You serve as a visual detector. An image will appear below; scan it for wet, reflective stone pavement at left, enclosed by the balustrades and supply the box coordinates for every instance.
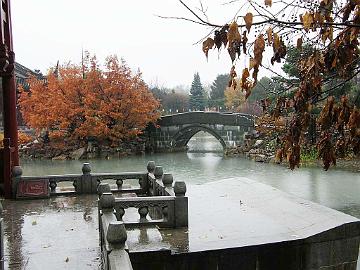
[2,195,101,270]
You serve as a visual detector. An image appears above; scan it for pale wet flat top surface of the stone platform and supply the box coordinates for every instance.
[128,178,360,253]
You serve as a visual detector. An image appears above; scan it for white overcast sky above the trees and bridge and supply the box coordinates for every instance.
[12,0,276,90]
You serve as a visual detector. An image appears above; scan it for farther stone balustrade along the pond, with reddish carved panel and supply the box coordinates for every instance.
[12,161,186,198]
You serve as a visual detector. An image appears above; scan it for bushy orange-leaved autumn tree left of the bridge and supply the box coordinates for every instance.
[19,56,159,146]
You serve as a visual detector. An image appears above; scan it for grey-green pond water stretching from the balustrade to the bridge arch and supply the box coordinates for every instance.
[21,134,360,218]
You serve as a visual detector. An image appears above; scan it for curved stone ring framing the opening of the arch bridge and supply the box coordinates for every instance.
[171,125,226,150]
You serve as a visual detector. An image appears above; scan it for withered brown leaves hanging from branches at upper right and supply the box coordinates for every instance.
[195,0,360,170]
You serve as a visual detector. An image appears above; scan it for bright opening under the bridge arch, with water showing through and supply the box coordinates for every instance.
[187,131,223,152]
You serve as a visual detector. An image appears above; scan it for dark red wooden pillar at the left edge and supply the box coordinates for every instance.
[0,0,19,198]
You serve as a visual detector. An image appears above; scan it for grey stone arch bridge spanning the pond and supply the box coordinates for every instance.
[146,112,254,152]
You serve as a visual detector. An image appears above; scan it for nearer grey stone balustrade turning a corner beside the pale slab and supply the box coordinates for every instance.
[97,166,188,270]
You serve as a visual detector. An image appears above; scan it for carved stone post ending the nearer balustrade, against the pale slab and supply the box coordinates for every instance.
[174,181,189,228]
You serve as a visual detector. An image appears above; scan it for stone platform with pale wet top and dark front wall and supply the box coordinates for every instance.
[127,178,360,270]
